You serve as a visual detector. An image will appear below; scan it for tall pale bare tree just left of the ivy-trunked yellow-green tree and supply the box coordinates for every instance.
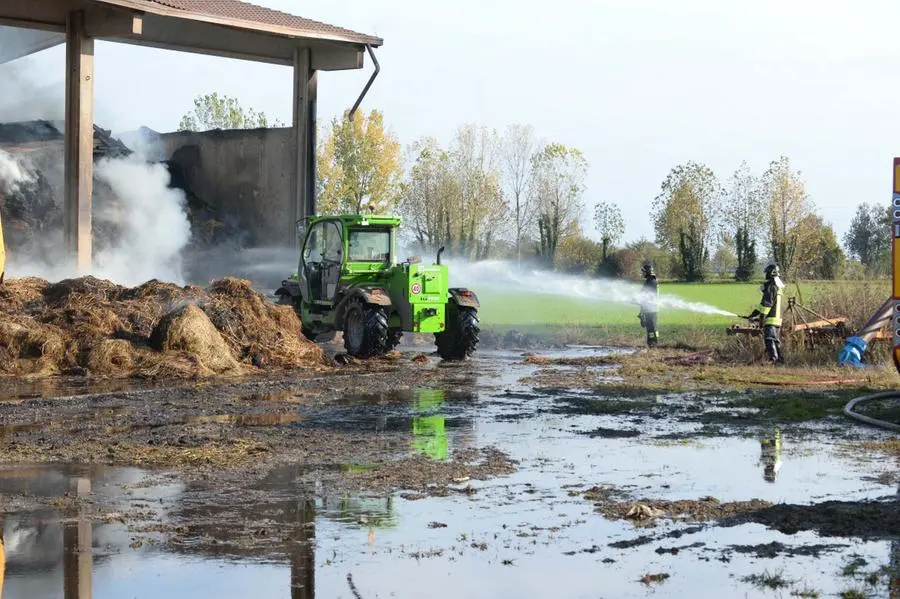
[501,125,535,262]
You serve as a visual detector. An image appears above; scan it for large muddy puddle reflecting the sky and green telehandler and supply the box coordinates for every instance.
[0,348,900,599]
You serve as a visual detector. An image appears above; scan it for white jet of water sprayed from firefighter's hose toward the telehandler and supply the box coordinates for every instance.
[447,260,735,316]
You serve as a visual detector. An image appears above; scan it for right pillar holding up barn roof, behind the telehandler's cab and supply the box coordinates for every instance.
[289,48,315,247]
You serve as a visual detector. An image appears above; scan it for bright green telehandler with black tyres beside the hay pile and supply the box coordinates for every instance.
[275,215,479,360]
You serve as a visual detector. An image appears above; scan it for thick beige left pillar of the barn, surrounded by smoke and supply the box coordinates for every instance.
[63,11,94,272]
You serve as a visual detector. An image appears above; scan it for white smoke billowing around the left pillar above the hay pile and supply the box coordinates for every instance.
[0,58,197,285]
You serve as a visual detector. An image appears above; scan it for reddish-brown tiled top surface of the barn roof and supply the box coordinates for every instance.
[147,0,382,46]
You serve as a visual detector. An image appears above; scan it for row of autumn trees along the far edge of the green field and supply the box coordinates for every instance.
[182,95,891,281]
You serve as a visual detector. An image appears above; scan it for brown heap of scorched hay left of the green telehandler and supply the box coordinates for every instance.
[0,277,325,378]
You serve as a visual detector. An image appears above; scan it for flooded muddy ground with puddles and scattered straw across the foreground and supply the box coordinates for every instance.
[0,347,900,597]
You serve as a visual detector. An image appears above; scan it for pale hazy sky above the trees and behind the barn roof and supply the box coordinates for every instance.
[0,0,900,245]
